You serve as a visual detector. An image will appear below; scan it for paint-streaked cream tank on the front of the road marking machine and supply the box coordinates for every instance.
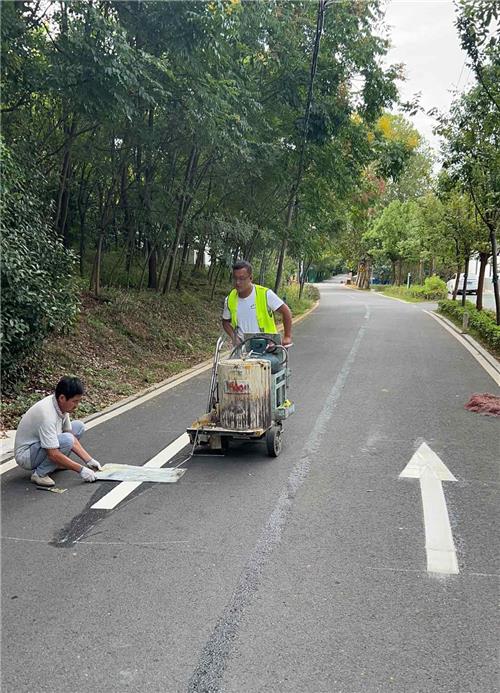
[218,358,272,431]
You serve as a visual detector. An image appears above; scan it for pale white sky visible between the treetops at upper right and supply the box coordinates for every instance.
[385,0,474,158]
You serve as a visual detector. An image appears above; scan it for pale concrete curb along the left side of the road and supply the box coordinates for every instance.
[0,299,320,464]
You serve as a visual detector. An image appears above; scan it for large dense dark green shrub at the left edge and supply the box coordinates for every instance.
[0,142,78,389]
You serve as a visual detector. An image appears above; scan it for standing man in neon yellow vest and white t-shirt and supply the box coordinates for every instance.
[222,260,292,347]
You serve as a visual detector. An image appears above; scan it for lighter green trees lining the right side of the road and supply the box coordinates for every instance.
[337,0,500,325]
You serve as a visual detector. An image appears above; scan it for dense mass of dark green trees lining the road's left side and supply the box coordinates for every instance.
[0,0,402,402]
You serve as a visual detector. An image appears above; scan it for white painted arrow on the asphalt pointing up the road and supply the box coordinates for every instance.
[399,443,459,575]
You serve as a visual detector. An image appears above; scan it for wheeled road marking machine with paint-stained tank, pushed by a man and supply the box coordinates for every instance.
[187,333,295,457]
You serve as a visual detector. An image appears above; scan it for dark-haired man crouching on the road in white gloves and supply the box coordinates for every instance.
[14,377,101,486]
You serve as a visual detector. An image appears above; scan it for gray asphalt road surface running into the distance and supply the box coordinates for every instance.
[1,283,500,693]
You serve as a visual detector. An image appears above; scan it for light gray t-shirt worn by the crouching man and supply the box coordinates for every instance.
[14,395,71,466]
